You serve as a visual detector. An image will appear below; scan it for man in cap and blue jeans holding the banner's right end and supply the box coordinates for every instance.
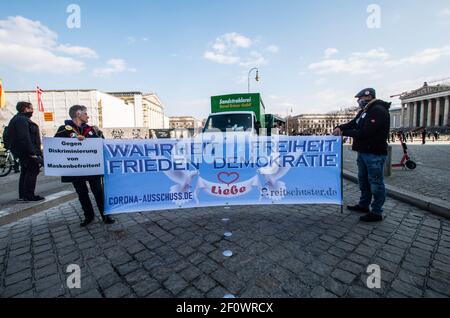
[333,88,391,222]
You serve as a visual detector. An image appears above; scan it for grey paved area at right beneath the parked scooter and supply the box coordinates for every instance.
[344,142,450,201]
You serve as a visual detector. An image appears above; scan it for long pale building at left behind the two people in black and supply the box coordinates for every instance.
[0,89,168,136]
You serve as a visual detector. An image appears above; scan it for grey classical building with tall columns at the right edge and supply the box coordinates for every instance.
[399,82,450,129]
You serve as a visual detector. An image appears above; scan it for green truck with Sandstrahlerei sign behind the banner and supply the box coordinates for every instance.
[203,94,266,134]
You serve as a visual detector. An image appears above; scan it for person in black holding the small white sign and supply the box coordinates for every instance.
[55,105,115,227]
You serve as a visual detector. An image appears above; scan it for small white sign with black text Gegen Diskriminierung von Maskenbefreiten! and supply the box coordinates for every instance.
[43,137,104,177]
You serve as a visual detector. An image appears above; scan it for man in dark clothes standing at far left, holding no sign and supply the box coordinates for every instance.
[8,102,45,202]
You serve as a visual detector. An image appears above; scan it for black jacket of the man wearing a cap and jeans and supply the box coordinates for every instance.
[339,99,391,155]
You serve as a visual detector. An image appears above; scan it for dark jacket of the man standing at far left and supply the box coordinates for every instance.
[7,113,42,158]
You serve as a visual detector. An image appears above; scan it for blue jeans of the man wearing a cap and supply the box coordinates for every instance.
[357,152,387,215]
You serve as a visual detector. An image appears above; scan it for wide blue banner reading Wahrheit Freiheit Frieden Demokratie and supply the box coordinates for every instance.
[104,136,342,214]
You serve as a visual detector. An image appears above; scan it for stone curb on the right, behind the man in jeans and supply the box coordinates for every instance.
[344,169,450,219]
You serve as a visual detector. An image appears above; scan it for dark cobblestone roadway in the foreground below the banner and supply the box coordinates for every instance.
[0,183,450,298]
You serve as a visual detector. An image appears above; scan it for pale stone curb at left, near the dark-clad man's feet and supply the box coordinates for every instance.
[0,191,77,226]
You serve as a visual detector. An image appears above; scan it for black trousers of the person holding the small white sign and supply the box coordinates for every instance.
[72,177,105,219]
